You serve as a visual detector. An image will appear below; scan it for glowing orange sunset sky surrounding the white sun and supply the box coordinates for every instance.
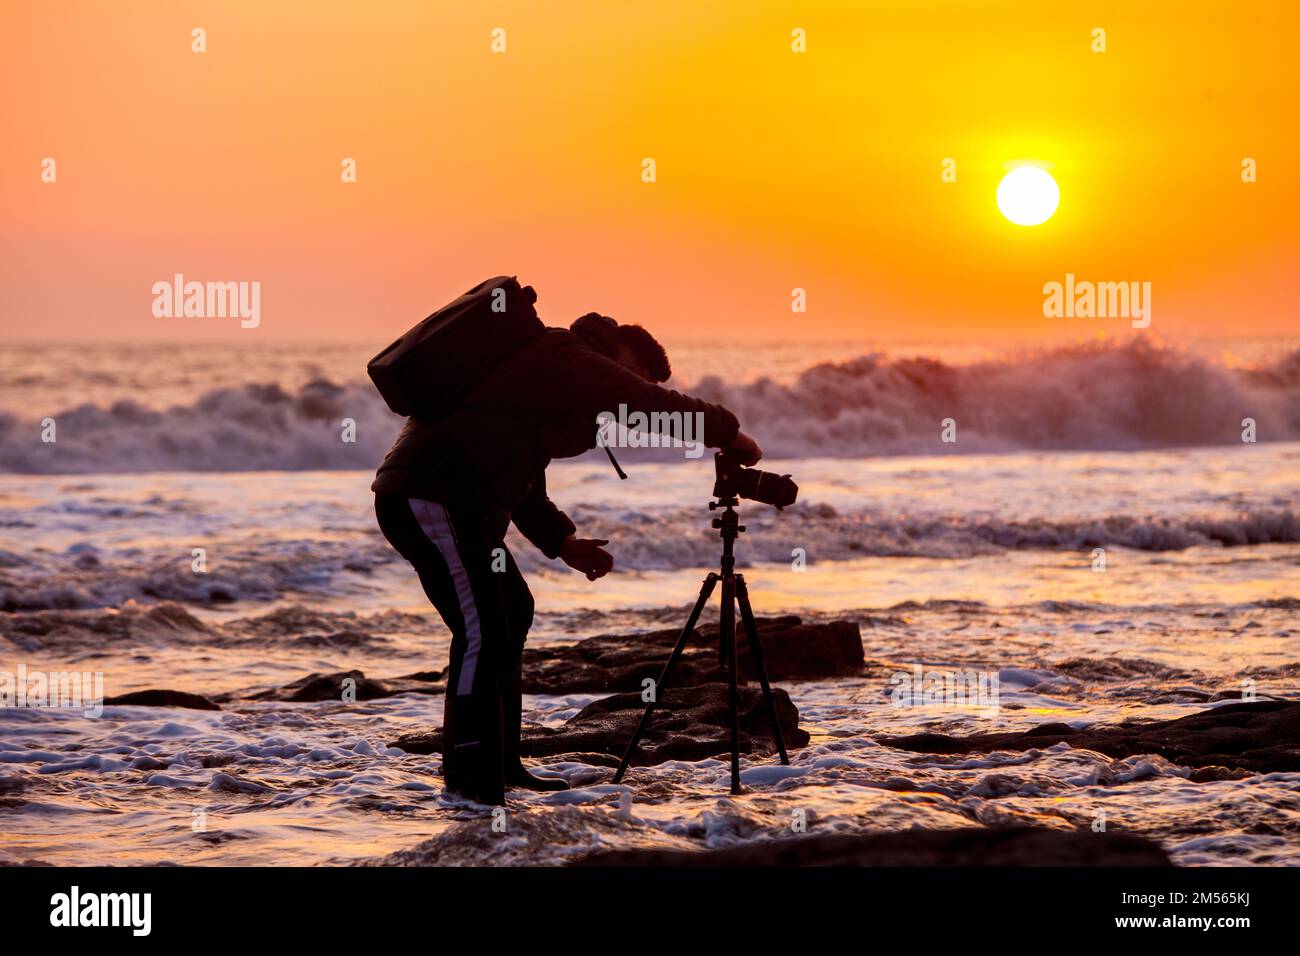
[0,0,1300,343]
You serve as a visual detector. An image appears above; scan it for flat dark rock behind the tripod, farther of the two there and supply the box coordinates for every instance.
[524,617,865,693]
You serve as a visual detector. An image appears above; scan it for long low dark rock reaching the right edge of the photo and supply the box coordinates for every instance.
[878,701,1300,779]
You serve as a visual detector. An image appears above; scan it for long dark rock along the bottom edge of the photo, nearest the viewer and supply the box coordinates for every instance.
[569,827,1173,866]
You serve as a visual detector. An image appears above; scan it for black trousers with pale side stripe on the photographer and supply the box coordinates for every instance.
[374,492,533,803]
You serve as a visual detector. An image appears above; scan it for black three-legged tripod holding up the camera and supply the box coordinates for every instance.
[614,489,790,793]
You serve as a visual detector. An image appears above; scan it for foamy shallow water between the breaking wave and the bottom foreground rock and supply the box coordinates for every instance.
[0,445,1300,865]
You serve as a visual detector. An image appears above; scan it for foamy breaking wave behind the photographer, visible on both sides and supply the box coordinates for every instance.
[0,339,1300,473]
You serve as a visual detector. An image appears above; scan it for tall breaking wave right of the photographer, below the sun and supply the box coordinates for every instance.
[696,339,1300,457]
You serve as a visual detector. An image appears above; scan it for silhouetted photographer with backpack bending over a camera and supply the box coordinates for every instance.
[368,277,762,804]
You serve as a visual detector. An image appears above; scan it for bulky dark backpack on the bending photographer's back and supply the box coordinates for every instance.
[365,276,545,420]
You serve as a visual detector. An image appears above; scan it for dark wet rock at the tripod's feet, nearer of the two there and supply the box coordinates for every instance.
[393,683,809,766]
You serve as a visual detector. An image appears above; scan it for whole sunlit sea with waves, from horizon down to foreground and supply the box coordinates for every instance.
[0,337,1300,866]
